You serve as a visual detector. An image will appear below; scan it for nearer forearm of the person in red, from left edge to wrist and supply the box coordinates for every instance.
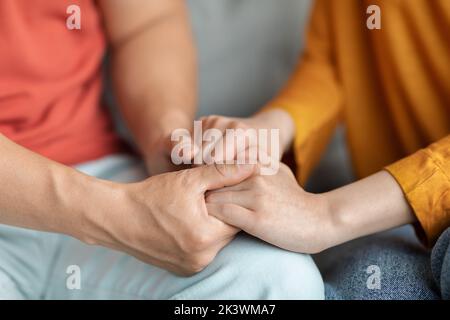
[0,134,114,240]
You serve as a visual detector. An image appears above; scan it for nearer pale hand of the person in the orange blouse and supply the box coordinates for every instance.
[206,164,335,253]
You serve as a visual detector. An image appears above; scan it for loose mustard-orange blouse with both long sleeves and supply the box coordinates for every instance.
[268,0,450,243]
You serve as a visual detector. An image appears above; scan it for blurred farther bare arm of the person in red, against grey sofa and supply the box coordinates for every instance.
[100,0,197,173]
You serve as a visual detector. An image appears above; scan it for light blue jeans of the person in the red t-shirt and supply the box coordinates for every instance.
[0,155,324,299]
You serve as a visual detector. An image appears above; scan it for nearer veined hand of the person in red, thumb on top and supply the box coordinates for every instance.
[82,165,254,275]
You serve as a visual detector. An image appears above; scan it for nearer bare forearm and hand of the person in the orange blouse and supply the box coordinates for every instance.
[207,165,415,253]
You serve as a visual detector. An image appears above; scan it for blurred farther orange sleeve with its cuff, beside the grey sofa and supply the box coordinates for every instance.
[265,0,342,183]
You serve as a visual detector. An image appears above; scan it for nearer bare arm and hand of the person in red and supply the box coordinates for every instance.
[0,134,252,274]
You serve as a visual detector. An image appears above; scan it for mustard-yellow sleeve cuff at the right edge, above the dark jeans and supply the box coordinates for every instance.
[386,136,450,245]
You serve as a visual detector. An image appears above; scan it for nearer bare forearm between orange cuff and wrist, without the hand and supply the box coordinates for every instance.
[324,171,416,246]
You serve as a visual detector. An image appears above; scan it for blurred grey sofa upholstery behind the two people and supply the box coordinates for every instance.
[107,0,351,191]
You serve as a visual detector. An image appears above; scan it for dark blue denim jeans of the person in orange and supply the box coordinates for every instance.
[315,226,450,300]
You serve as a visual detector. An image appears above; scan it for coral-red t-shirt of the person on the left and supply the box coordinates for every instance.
[0,0,122,165]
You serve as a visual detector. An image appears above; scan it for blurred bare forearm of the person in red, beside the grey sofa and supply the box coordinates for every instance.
[112,2,197,154]
